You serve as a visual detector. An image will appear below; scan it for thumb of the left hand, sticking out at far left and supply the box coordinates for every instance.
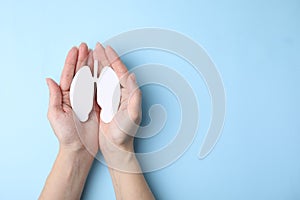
[46,78,62,110]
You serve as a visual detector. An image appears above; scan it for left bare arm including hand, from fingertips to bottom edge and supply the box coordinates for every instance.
[39,43,99,200]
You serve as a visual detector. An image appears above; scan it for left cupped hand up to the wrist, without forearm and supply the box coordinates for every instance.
[46,43,100,156]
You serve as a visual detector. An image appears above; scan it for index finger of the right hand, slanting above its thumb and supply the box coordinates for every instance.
[105,46,128,87]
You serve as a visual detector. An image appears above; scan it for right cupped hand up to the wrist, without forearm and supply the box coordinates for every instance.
[93,43,141,157]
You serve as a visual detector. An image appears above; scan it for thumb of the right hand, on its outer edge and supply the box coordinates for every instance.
[127,74,142,122]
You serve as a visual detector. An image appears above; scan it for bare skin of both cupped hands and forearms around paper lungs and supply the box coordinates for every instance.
[39,43,154,200]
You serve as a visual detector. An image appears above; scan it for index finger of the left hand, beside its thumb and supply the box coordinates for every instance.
[60,47,78,91]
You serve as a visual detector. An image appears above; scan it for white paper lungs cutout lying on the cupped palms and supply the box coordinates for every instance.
[70,61,120,123]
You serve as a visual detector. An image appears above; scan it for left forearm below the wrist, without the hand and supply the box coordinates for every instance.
[39,148,93,200]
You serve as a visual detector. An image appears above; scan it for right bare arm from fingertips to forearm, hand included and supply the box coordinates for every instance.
[94,43,154,200]
